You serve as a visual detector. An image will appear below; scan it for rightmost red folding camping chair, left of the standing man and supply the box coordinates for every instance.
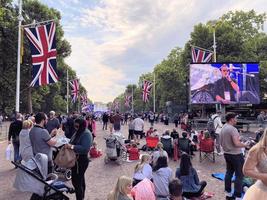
[199,138,215,163]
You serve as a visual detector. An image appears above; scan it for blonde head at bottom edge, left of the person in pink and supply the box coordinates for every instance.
[108,176,133,200]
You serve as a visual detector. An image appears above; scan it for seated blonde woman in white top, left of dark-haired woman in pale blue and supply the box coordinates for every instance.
[133,154,152,186]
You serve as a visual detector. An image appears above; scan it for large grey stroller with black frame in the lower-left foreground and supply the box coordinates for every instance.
[12,153,74,200]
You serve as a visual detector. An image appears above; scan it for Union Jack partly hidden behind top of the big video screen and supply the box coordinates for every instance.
[191,46,213,63]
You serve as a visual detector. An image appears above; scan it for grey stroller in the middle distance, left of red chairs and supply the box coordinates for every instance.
[104,135,127,165]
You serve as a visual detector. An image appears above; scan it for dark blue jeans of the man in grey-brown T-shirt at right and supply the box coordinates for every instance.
[224,153,244,197]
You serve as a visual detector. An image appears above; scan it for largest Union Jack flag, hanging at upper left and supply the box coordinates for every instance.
[25,22,58,87]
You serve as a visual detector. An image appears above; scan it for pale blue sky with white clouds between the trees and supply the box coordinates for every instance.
[39,0,267,103]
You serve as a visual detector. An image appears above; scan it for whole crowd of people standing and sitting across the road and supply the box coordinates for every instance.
[4,111,267,200]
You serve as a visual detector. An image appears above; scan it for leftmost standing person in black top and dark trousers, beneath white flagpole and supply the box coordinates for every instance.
[8,113,23,162]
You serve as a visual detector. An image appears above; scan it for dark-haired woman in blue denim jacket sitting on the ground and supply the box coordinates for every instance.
[176,153,207,199]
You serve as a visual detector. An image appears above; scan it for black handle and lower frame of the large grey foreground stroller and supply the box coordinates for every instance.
[11,161,74,200]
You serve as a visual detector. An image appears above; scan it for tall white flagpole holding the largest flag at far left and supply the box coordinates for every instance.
[16,0,23,112]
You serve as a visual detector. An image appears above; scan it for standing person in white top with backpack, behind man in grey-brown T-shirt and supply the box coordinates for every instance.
[214,111,223,156]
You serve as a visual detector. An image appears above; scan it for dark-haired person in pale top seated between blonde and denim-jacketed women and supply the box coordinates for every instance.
[152,156,172,200]
